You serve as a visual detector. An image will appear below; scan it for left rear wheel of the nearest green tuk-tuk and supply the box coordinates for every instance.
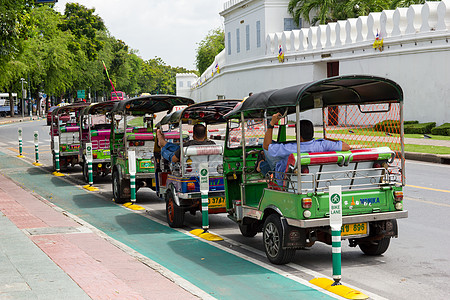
[263,214,295,265]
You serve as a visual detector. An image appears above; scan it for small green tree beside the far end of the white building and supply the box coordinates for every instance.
[196,28,225,74]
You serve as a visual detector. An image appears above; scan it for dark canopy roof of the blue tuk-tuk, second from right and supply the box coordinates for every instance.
[156,99,241,127]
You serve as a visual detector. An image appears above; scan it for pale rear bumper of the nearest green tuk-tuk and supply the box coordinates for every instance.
[286,210,408,228]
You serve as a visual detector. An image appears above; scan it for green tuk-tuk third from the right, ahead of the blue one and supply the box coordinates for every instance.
[110,95,194,203]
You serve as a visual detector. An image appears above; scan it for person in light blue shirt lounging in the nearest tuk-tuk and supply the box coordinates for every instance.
[256,113,350,176]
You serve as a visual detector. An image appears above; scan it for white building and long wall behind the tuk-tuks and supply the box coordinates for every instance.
[177,0,450,125]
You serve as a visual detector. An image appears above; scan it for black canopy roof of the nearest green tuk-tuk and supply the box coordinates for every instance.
[226,75,403,118]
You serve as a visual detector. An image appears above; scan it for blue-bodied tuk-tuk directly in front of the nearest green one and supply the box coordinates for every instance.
[157,100,240,227]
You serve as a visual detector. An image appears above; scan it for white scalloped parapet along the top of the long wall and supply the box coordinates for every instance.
[192,0,450,86]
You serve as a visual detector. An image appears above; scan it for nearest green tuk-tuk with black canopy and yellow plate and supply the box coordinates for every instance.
[224,75,408,264]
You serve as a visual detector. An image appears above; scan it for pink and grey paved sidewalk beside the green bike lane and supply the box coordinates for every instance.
[0,175,198,300]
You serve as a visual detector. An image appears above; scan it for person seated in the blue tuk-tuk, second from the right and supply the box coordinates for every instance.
[156,124,216,162]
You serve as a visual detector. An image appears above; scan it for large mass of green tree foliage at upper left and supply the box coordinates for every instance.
[0,0,195,106]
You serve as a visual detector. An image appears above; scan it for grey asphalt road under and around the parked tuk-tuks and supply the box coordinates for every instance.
[0,120,450,299]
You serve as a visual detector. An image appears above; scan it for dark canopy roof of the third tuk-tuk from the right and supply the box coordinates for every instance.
[114,95,194,115]
